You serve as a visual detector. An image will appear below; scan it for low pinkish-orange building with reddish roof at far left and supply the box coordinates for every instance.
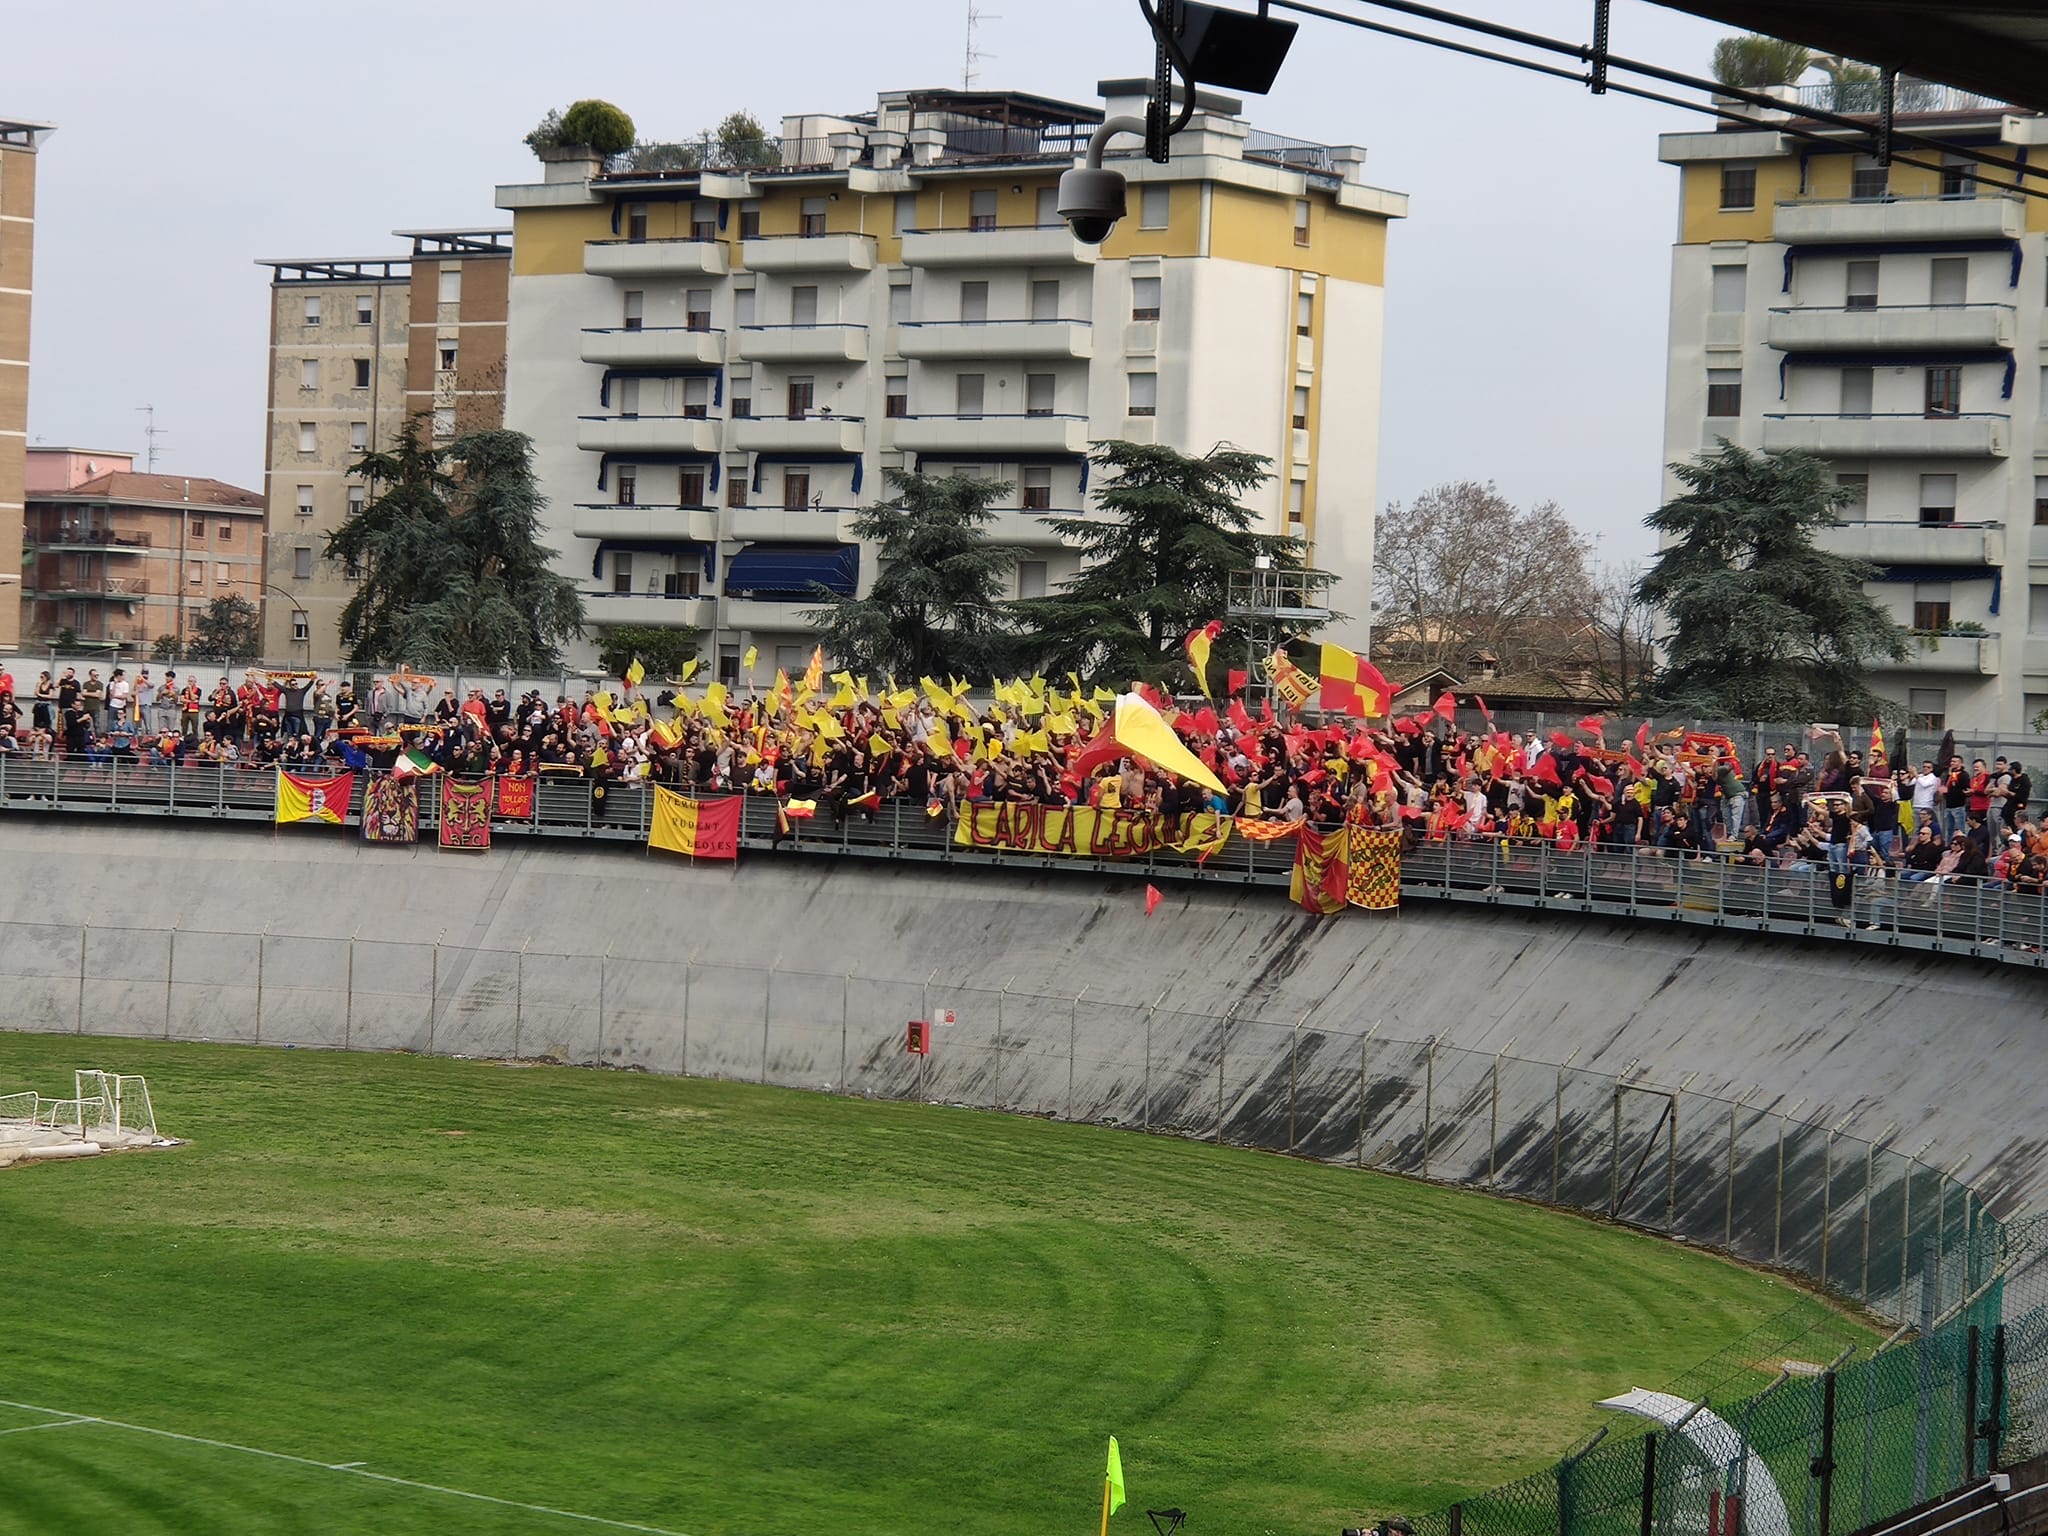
[20,449,264,657]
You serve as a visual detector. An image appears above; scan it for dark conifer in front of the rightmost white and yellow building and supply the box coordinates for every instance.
[1636,442,1907,721]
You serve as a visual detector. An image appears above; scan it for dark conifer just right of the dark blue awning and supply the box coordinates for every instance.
[807,469,1018,678]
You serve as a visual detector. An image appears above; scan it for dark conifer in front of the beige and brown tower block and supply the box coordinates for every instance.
[326,416,584,672]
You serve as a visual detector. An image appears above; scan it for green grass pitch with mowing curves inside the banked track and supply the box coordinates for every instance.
[0,1034,1826,1536]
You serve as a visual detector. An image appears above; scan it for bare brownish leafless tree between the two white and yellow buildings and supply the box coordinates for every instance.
[1374,479,1593,674]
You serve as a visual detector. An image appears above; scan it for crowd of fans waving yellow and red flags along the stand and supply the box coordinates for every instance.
[0,668,2048,913]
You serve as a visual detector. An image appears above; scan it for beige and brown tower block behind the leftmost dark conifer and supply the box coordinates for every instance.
[258,229,512,666]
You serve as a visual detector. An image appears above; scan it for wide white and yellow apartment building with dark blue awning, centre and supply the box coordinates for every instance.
[498,80,1407,680]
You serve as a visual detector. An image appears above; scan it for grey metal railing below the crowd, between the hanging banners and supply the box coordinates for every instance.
[0,761,2048,969]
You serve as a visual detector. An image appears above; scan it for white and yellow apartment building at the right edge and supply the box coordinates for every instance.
[1659,82,2048,735]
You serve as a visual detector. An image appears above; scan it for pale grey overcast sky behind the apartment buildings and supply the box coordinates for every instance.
[0,0,1720,561]
